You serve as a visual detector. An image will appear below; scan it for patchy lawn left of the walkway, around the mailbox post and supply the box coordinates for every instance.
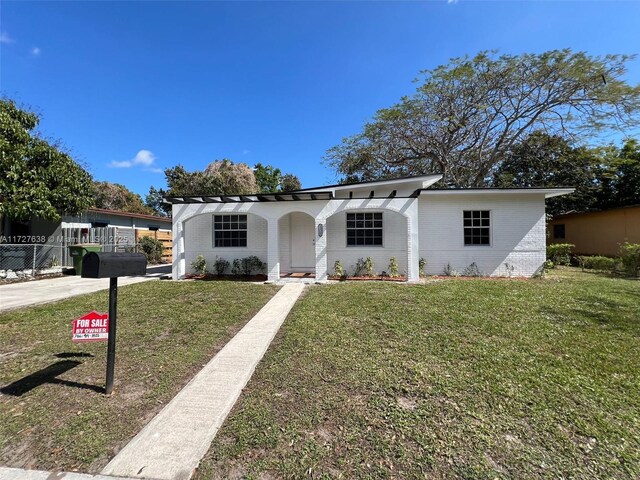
[0,282,277,472]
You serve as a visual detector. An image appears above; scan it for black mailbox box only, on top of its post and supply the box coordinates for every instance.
[82,252,147,278]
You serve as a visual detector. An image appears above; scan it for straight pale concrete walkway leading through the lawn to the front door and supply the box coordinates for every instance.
[102,283,304,480]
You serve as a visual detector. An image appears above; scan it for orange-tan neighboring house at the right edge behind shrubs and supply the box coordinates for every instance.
[547,205,640,256]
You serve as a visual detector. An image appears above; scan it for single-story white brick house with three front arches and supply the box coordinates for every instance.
[166,175,573,282]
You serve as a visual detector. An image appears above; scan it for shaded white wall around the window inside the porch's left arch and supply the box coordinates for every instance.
[184,213,267,273]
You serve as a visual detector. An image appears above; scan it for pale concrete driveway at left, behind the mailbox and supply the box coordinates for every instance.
[0,265,171,312]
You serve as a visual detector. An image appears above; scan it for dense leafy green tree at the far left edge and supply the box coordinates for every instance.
[0,98,93,224]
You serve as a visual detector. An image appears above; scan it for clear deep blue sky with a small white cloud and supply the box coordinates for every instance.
[0,0,640,195]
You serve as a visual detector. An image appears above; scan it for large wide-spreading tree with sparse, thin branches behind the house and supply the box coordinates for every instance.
[325,49,640,187]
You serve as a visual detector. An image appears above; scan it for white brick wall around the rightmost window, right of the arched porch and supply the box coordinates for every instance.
[418,192,546,276]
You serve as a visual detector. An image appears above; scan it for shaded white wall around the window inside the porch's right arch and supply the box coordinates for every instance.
[327,210,407,275]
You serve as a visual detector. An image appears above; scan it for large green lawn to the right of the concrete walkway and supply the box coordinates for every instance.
[196,270,640,480]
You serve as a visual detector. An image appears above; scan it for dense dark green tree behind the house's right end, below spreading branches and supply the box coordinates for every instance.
[492,131,604,215]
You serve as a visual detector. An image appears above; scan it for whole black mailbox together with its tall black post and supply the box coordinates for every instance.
[82,252,147,395]
